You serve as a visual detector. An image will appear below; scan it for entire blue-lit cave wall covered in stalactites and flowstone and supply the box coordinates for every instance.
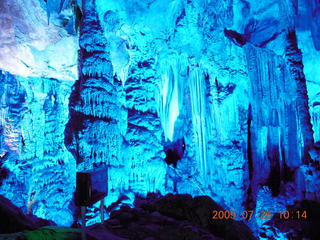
[0,0,320,233]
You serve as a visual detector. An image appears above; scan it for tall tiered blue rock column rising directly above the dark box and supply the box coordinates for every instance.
[69,1,127,174]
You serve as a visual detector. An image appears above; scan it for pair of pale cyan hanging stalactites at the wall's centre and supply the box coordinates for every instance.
[158,55,208,175]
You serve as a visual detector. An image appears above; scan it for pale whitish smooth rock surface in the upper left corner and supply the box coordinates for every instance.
[0,0,78,80]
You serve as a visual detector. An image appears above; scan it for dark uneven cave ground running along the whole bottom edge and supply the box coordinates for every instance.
[0,193,320,240]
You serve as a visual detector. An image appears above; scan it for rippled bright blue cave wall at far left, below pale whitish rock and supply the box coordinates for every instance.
[0,72,76,225]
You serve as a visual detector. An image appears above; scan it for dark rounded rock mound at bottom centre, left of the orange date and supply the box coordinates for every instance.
[101,194,256,240]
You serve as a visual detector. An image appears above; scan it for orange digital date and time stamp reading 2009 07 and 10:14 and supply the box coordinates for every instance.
[211,210,308,220]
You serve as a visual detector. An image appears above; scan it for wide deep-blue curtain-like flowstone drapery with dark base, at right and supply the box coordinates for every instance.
[245,44,303,203]
